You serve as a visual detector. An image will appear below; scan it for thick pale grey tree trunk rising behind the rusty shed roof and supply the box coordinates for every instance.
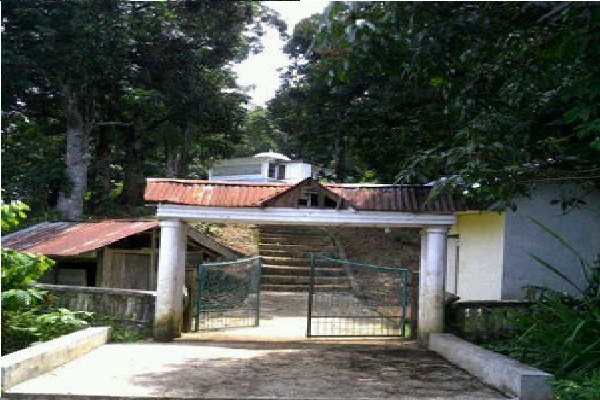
[57,83,90,221]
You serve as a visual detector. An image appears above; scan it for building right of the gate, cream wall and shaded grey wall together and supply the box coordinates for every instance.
[446,184,600,301]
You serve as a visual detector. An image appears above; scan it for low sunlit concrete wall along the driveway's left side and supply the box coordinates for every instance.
[1,327,110,390]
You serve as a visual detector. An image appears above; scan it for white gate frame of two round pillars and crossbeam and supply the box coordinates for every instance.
[154,211,456,344]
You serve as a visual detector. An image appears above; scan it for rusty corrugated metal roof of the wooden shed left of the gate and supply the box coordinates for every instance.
[2,220,158,256]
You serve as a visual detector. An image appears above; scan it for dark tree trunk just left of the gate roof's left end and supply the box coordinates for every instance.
[121,121,146,207]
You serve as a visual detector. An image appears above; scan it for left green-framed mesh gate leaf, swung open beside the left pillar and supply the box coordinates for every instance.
[192,257,262,332]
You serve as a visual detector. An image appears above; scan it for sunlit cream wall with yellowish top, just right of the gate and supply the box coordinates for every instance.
[446,211,504,300]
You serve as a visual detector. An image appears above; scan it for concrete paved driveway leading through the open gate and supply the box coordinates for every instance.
[3,294,506,400]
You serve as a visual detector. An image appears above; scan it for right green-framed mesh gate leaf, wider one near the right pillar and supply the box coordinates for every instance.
[306,254,409,337]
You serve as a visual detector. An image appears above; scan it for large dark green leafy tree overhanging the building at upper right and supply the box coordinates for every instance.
[315,2,600,208]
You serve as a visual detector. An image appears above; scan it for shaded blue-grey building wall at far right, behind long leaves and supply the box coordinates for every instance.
[502,184,600,299]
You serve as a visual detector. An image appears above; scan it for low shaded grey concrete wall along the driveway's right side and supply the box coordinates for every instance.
[429,333,554,400]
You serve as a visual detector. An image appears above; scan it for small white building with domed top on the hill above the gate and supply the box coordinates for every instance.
[208,151,321,183]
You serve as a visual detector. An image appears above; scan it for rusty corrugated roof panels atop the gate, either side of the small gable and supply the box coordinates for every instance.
[144,178,466,213]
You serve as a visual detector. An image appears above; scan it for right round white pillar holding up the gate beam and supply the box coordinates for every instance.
[417,226,448,343]
